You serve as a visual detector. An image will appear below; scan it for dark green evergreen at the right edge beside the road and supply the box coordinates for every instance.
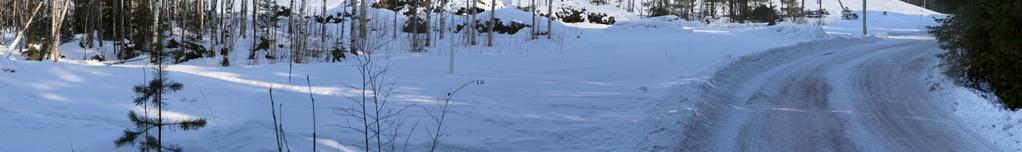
[930,0,1022,109]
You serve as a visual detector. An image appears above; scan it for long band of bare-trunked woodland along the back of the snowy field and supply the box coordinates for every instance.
[0,0,838,66]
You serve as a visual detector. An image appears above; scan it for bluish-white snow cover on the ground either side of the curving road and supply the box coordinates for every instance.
[0,0,1020,151]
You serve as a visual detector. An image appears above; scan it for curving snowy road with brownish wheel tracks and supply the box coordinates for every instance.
[680,39,1000,151]
